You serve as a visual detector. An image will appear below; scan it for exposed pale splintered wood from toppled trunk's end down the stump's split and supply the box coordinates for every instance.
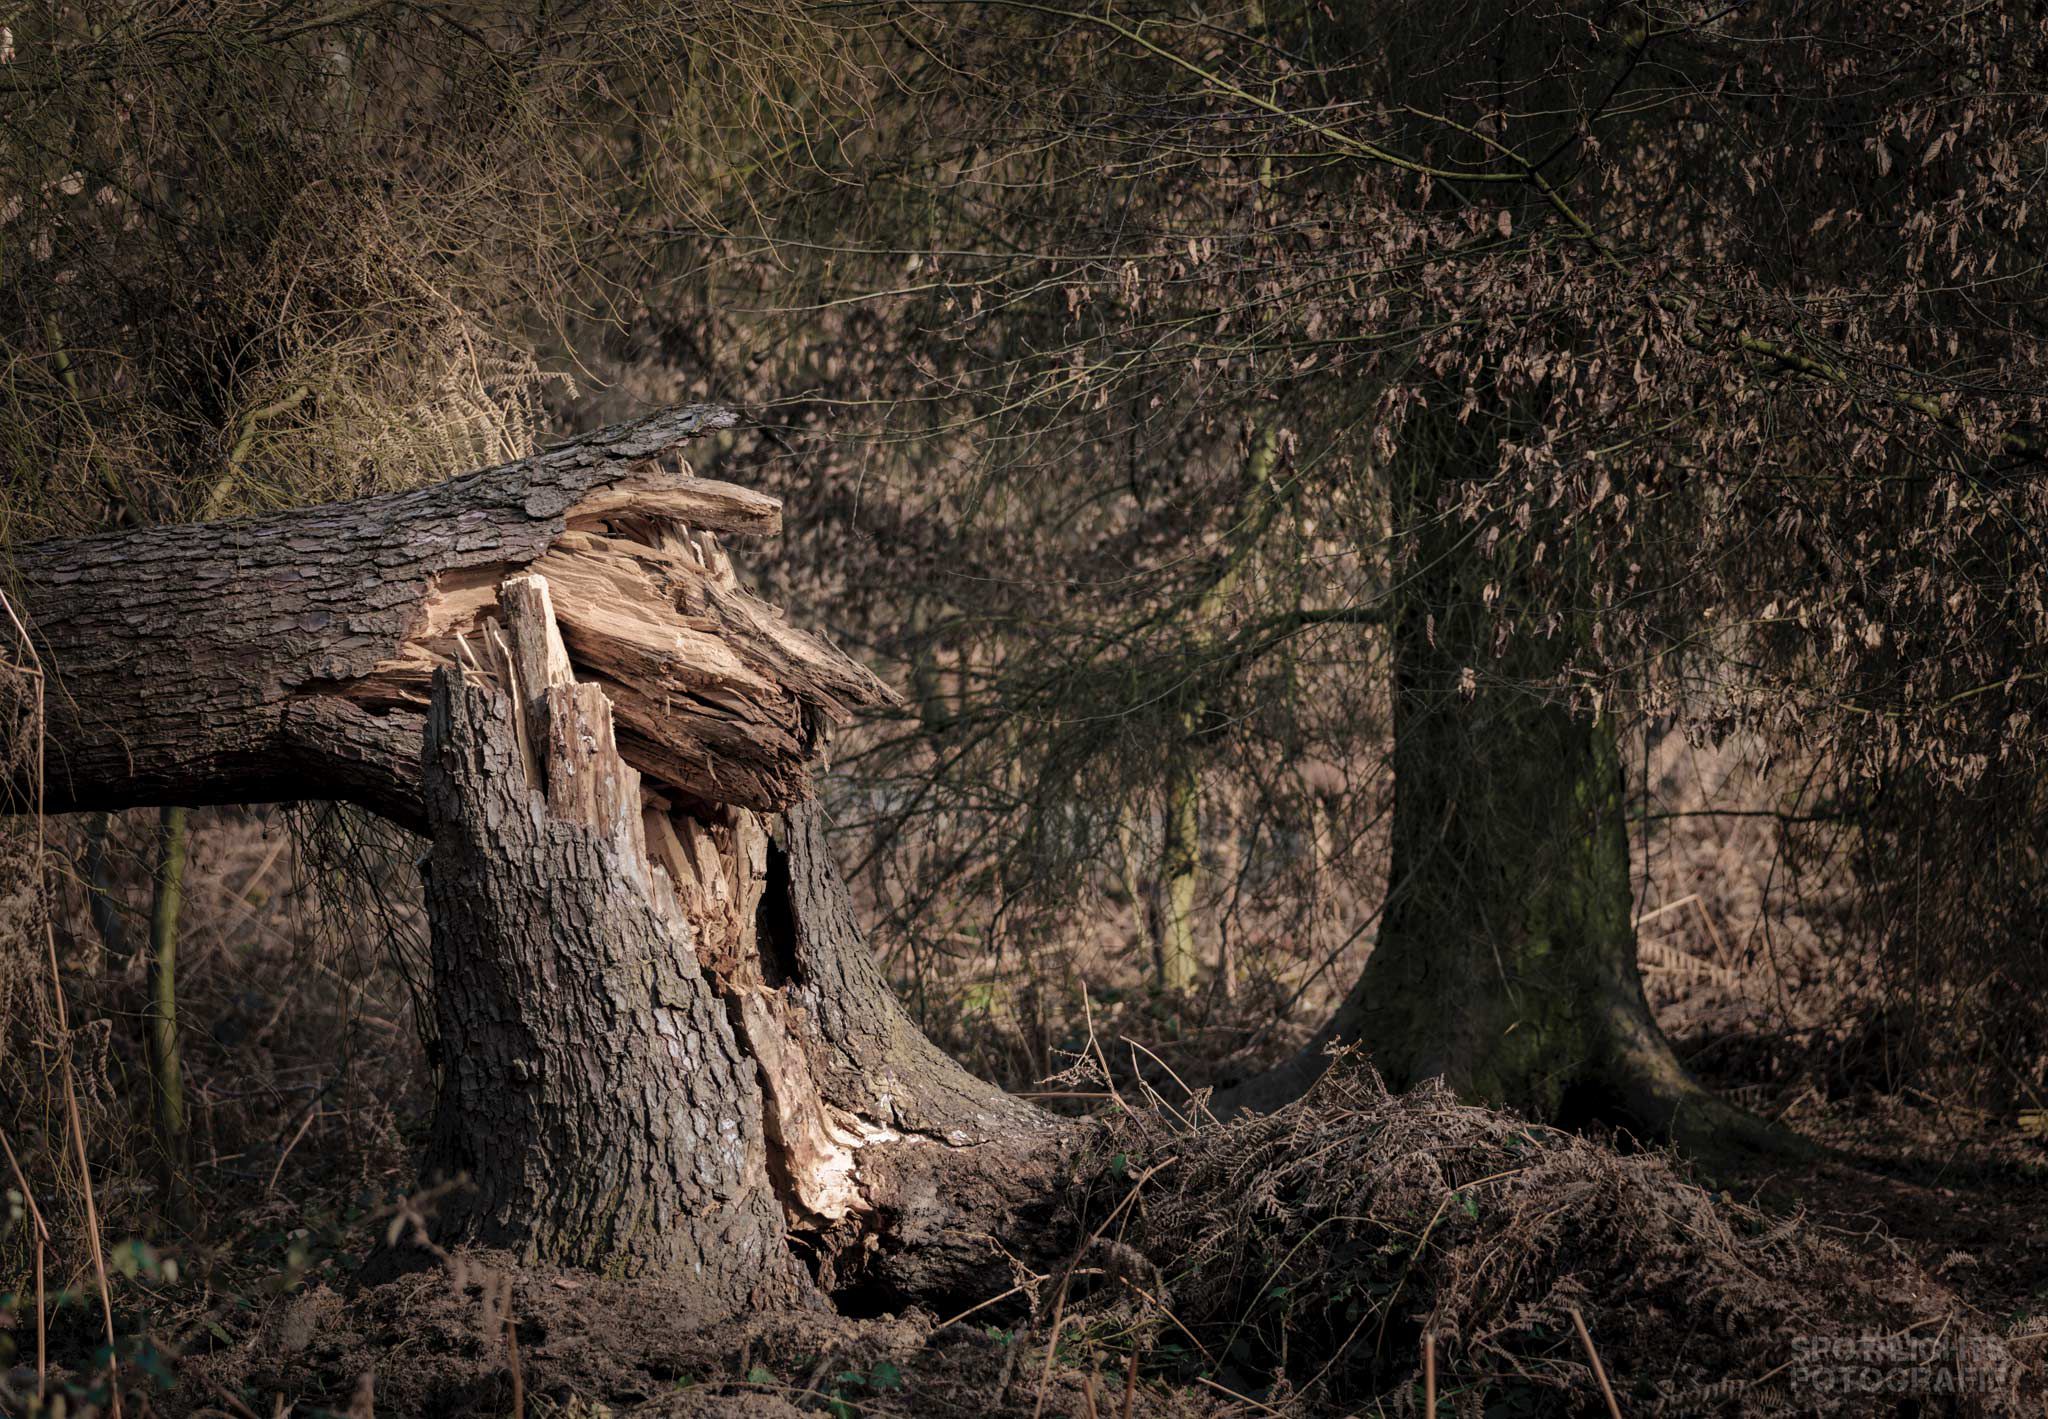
[415,456,899,1227]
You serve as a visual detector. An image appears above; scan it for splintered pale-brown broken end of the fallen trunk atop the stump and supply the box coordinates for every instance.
[331,473,889,811]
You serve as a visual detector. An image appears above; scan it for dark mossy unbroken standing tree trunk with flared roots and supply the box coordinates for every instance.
[1223,432,1784,1155]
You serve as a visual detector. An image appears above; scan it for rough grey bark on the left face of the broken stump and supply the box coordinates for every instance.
[422,670,807,1310]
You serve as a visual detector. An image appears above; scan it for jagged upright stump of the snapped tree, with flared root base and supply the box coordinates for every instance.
[411,575,1061,1315]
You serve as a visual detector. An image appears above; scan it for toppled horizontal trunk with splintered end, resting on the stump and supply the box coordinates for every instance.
[10,407,881,827]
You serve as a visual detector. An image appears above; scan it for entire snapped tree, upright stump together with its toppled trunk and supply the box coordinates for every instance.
[14,410,1069,1315]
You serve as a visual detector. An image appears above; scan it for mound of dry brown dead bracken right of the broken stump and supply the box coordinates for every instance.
[1069,1065,2042,1415]
